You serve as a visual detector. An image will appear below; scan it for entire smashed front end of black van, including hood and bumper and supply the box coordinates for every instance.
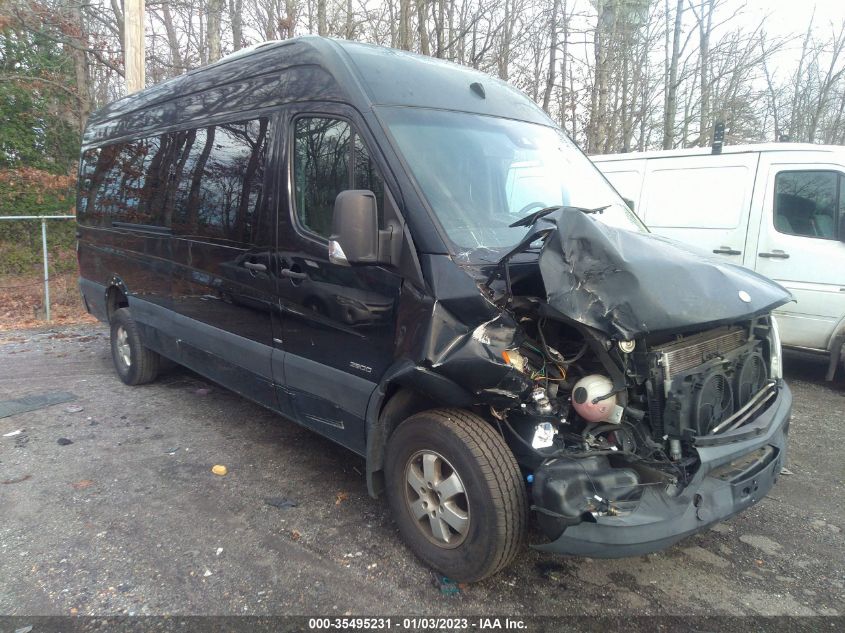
[415,208,791,557]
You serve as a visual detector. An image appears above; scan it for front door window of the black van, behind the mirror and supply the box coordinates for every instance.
[293,117,384,237]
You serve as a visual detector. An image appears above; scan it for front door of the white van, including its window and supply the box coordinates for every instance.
[749,155,845,350]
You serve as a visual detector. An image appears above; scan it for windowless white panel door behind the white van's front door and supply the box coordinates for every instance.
[637,152,759,264]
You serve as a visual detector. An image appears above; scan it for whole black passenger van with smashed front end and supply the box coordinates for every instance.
[77,37,791,581]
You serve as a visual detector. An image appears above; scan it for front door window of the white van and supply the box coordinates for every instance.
[774,171,843,240]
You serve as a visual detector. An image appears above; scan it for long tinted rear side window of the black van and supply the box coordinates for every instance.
[79,118,270,243]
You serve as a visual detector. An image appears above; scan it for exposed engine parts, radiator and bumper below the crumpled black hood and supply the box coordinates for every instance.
[520,316,791,557]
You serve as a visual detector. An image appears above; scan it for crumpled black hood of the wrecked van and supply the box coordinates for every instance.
[530,209,792,340]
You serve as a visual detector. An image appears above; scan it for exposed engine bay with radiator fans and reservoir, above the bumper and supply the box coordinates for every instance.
[490,298,776,536]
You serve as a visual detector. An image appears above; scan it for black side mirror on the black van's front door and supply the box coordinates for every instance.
[329,189,392,266]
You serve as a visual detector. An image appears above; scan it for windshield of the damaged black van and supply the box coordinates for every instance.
[378,107,646,259]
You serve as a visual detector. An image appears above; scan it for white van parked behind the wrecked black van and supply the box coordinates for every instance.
[591,143,845,380]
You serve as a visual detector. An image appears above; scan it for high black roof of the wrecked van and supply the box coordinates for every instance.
[83,36,554,145]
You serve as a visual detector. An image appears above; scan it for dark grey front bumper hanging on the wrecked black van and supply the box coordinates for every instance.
[532,383,792,558]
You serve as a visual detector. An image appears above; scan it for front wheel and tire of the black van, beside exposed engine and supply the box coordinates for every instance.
[385,409,527,582]
